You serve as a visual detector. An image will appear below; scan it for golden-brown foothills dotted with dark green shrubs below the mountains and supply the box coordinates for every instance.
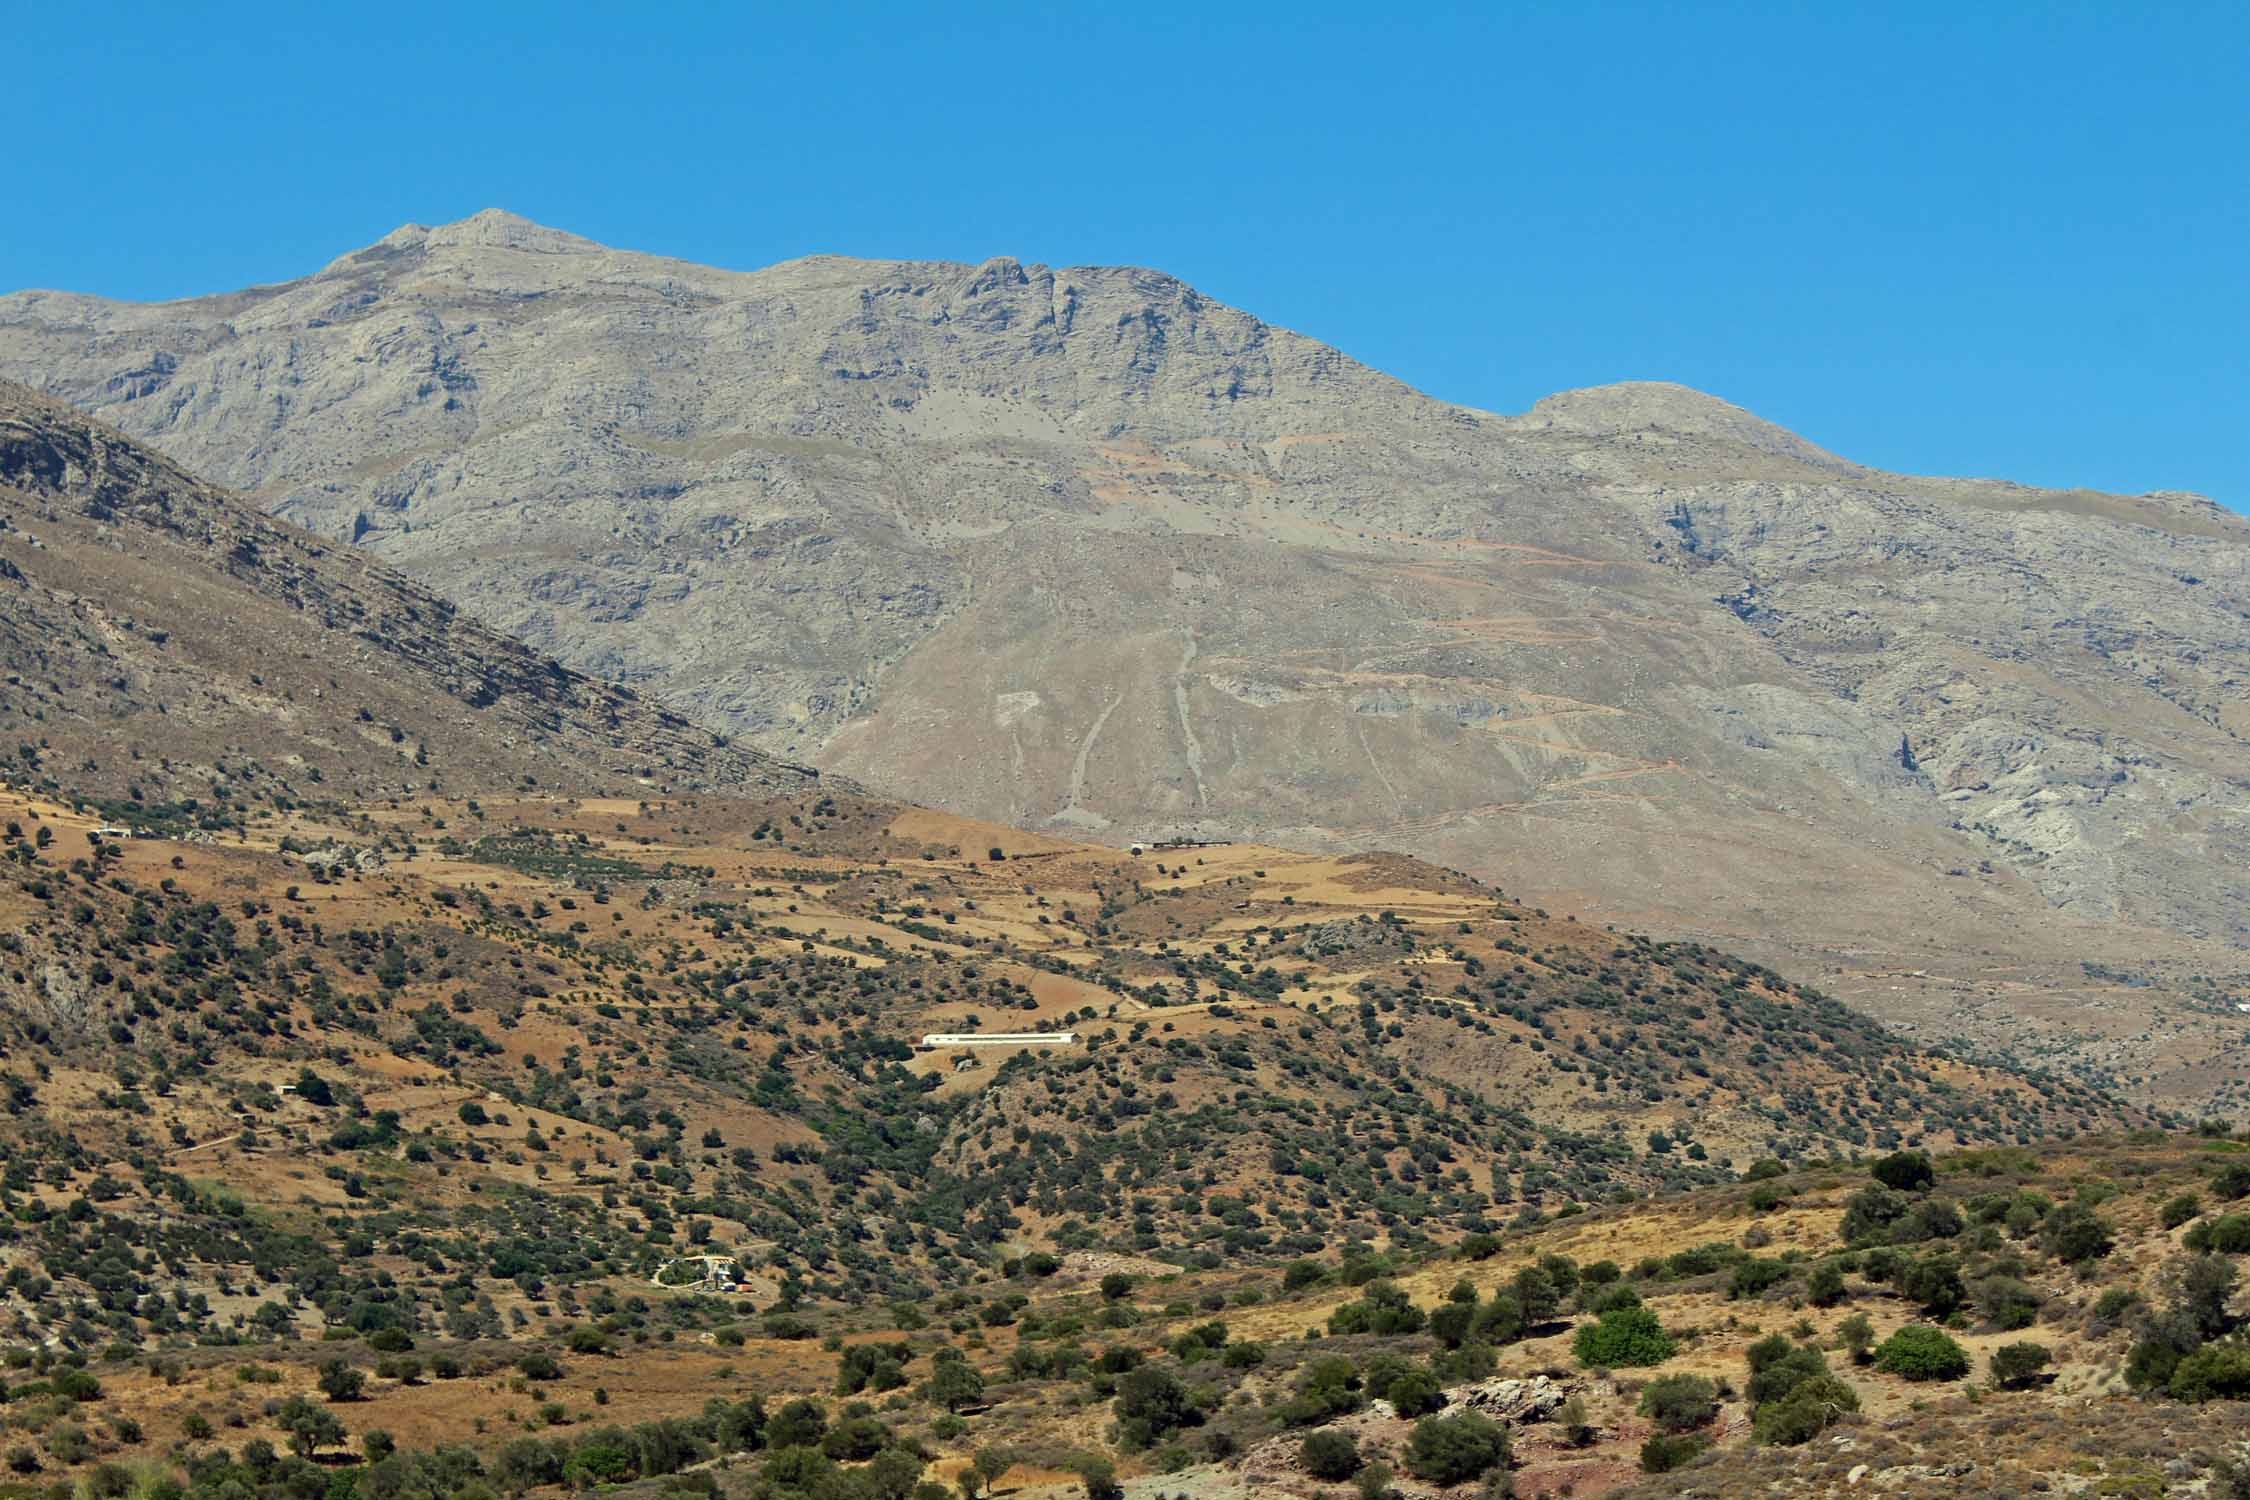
[0,366,2250,1500]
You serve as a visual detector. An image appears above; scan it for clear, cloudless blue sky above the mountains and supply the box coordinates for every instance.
[0,0,2250,508]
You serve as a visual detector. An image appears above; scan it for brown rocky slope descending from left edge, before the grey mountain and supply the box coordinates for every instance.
[0,385,817,823]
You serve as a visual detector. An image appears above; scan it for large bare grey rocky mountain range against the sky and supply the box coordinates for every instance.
[0,211,2250,1100]
